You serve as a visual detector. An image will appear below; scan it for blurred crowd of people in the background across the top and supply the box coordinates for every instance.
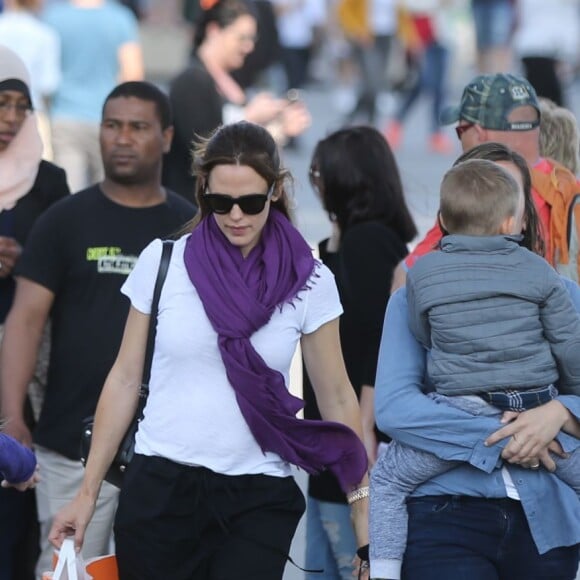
[0,0,580,161]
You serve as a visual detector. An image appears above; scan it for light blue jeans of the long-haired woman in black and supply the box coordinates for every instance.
[305,496,356,580]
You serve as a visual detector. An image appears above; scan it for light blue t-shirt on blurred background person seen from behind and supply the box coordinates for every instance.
[43,2,138,123]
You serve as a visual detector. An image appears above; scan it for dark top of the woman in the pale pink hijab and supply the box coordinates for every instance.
[0,161,70,324]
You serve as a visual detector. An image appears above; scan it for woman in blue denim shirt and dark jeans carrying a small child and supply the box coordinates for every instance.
[375,144,580,580]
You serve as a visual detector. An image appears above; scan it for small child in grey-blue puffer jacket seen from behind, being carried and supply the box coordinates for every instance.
[370,159,580,580]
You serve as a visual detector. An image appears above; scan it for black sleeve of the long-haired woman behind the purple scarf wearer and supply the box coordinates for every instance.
[340,223,407,387]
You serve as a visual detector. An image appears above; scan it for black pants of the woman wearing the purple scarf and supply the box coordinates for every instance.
[115,455,305,580]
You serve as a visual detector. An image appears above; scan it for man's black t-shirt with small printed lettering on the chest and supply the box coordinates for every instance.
[17,186,194,459]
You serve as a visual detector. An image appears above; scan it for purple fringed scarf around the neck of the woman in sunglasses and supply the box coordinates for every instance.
[184,208,367,491]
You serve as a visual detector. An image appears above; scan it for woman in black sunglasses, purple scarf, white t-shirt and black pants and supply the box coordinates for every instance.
[51,122,368,580]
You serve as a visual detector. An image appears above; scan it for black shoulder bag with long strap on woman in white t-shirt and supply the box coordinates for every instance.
[81,240,173,487]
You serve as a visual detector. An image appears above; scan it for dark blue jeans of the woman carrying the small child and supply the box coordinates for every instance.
[402,496,578,580]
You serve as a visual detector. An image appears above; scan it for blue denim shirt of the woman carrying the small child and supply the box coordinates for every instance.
[375,280,580,554]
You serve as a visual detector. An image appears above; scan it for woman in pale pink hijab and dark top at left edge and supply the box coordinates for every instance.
[0,46,70,580]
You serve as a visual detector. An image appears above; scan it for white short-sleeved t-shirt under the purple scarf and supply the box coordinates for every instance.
[122,236,342,477]
